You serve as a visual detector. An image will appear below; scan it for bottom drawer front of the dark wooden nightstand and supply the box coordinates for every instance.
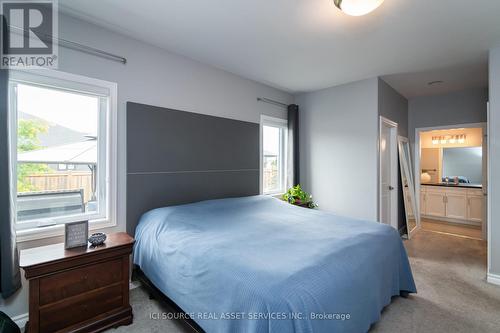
[40,283,123,333]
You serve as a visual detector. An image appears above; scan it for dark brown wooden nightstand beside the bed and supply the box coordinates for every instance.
[20,232,134,333]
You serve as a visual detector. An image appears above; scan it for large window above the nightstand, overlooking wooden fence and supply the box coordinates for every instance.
[9,70,116,233]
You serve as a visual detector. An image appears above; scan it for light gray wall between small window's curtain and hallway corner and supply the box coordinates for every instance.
[295,78,378,220]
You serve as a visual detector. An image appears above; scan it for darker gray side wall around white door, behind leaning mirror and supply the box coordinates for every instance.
[378,79,408,230]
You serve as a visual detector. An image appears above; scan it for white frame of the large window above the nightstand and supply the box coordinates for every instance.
[8,69,118,242]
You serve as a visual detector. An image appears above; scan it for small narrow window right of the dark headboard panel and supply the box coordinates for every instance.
[261,116,287,194]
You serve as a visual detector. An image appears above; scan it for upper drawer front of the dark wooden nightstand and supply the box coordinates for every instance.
[40,255,123,305]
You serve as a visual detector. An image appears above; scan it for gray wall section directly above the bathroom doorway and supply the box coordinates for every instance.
[408,88,488,142]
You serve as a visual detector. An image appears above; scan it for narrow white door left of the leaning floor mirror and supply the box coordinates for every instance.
[380,117,398,229]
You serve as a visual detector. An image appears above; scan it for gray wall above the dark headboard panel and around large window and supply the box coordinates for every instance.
[0,16,293,316]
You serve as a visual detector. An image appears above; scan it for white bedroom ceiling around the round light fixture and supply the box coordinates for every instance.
[59,0,500,97]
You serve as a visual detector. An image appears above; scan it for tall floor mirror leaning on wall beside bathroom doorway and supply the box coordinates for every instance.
[398,137,420,239]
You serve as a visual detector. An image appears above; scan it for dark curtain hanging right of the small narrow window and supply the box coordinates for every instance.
[287,104,300,187]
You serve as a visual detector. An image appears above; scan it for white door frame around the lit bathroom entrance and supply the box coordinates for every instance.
[413,122,490,240]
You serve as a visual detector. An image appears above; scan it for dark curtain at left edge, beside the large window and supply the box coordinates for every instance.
[0,70,21,298]
